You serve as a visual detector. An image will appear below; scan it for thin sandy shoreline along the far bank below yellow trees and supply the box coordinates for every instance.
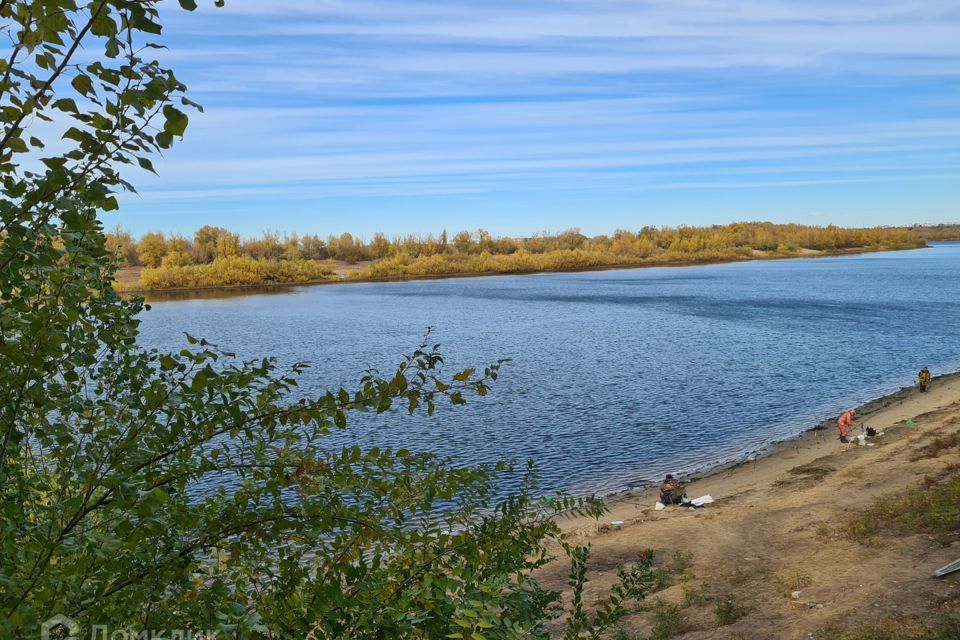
[117,244,930,302]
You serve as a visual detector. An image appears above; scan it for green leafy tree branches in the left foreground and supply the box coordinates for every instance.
[0,0,651,640]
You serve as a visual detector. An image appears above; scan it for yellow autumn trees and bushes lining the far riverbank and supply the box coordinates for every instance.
[108,222,924,289]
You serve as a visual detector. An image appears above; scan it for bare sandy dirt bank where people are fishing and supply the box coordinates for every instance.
[541,376,960,640]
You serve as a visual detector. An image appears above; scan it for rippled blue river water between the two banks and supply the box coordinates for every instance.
[135,243,960,493]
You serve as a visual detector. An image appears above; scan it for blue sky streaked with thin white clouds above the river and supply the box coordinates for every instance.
[114,0,960,237]
